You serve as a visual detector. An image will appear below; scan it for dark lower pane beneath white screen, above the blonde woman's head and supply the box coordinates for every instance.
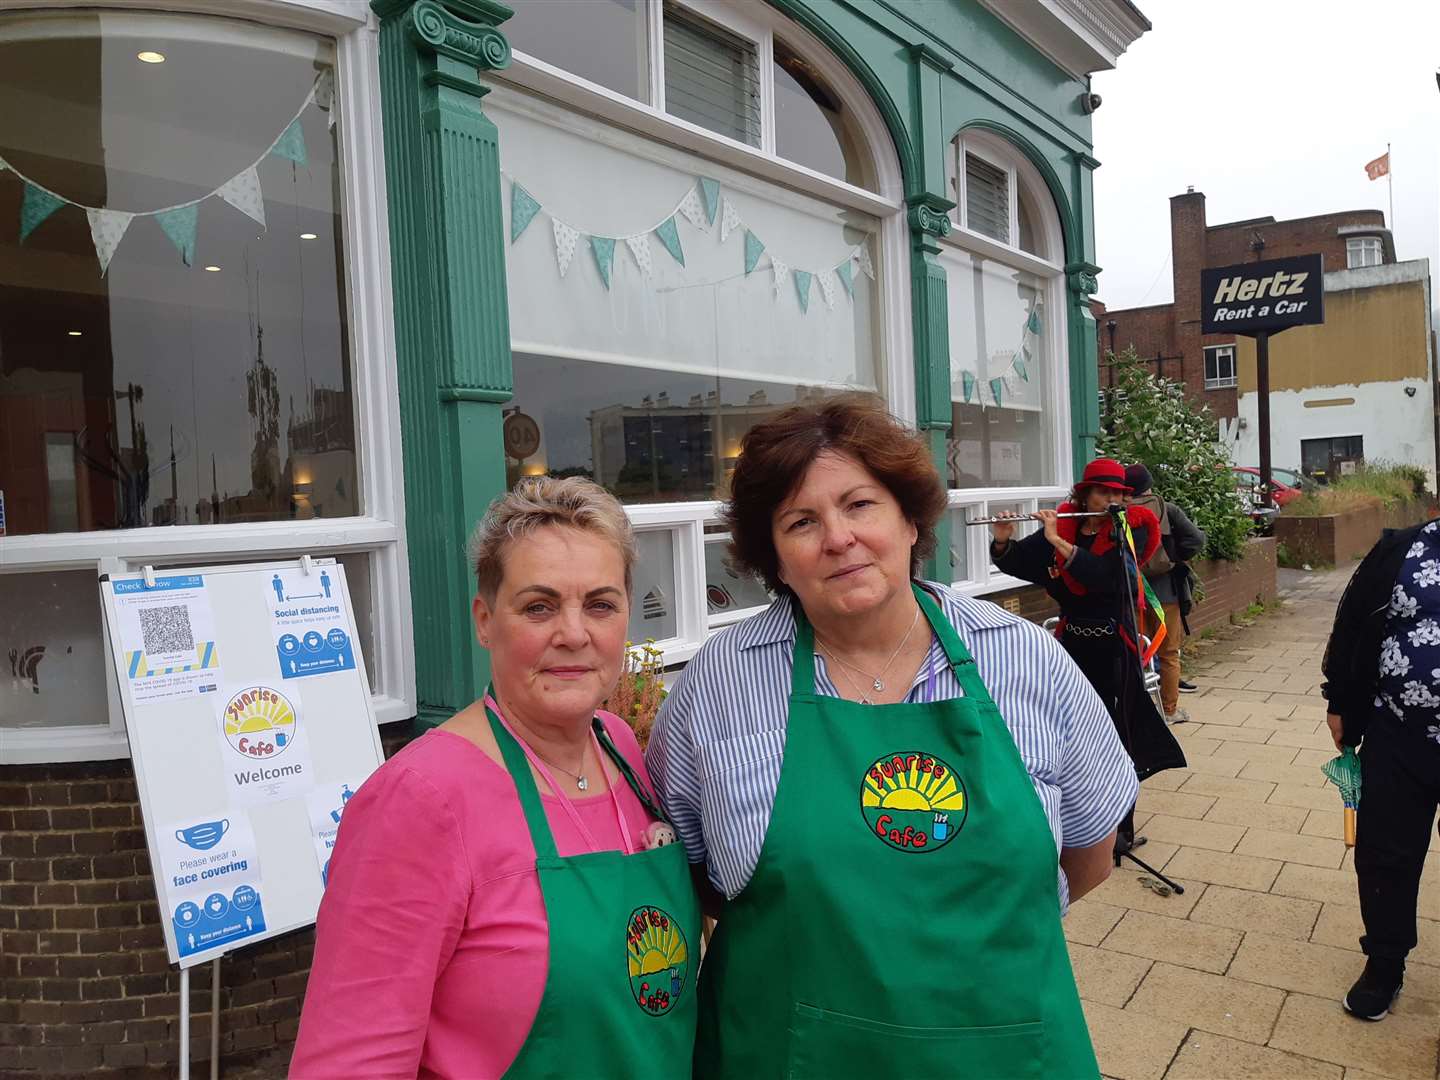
[505,353,846,503]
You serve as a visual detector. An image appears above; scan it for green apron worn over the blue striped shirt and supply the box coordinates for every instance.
[696,586,1099,1080]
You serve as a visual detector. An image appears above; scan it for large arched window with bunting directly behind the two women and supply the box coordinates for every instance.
[485,0,913,662]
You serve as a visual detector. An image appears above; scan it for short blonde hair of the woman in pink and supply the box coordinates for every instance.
[468,477,635,603]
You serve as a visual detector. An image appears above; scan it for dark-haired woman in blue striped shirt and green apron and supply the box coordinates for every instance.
[647,396,1136,1077]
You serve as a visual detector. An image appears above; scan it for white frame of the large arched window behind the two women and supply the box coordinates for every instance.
[492,0,916,668]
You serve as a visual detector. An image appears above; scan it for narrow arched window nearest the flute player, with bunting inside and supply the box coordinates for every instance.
[939,130,1070,592]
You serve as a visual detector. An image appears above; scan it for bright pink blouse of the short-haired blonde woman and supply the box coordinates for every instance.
[289,713,651,1080]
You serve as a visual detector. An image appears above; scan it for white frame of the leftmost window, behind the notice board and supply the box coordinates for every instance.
[0,0,418,765]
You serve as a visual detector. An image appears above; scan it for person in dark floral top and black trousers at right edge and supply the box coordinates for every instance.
[1320,521,1440,1020]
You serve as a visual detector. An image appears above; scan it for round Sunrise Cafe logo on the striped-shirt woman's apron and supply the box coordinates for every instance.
[860,750,969,852]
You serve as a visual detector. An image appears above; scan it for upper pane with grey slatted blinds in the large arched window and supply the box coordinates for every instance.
[664,6,760,147]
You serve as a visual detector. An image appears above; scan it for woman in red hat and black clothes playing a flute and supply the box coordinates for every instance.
[991,458,1184,851]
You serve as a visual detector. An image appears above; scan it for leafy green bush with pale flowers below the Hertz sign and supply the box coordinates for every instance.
[1099,348,1253,560]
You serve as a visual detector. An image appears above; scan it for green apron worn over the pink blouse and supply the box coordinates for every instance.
[485,696,700,1080]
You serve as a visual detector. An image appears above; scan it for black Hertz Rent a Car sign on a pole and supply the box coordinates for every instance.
[1200,255,1325,336]
